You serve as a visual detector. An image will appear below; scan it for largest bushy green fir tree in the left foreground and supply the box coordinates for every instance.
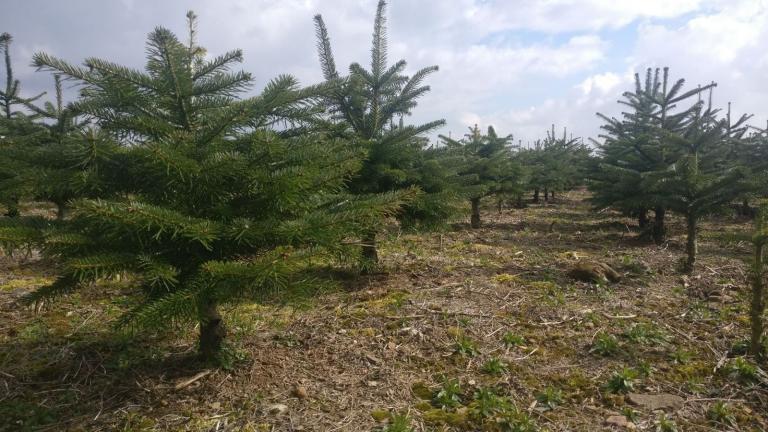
[13,12,403,359]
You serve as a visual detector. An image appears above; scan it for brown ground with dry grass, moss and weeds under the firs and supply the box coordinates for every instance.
[0,191,768,432]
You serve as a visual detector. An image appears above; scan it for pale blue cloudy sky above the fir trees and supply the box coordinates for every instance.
[0,0,768,145]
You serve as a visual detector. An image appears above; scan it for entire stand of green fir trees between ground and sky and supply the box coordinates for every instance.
[0,0,768,368]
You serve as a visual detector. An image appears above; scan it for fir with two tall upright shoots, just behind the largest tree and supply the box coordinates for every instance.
[315,0,453,265]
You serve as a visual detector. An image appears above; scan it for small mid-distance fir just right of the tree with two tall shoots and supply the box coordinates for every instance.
[440,125,522,228]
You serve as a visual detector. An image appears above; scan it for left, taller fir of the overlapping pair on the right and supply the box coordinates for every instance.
[590,68,714,243]
